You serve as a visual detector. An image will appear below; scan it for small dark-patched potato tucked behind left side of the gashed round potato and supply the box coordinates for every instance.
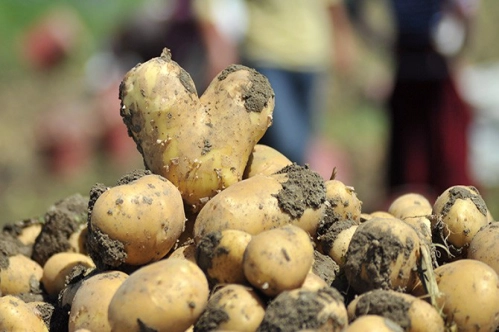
[196,229,251,286]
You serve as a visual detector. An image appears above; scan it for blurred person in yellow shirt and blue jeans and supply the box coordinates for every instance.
[194,0,353,166]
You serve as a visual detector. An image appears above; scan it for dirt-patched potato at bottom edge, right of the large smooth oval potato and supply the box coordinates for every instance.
[194,284,265,332]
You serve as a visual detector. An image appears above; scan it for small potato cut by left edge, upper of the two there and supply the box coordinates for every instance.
[0,254,43,295]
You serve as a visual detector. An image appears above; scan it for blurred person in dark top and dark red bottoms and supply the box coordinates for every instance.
[349,0,477,198]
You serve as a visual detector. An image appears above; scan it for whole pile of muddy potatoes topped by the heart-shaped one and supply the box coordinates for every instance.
[0,50,499,332]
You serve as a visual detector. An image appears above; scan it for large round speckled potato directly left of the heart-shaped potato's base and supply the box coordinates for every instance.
[87,174,186,268]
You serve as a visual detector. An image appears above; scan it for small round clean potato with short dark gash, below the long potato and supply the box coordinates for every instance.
[243,225,314,296]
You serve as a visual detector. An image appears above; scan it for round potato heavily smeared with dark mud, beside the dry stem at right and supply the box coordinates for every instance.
[344,218,431,293]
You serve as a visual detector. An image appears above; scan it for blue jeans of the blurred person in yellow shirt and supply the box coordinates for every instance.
[253,66,321,165]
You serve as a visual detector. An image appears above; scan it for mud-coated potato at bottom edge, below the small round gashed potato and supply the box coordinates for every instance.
[257,287,348,332]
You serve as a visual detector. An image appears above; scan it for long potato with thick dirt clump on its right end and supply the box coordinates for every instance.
[194,164,326,242]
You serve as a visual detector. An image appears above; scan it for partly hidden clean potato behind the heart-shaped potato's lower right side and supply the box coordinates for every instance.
[243,144,293,179]
